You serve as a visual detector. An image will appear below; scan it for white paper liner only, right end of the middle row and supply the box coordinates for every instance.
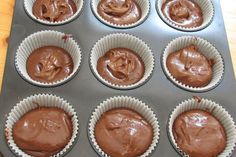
[162,36,224,92]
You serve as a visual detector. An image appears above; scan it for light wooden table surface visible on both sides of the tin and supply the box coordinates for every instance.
[0,0,236,91]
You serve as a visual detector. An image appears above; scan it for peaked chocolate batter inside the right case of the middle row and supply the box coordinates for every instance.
[166,45,214,87]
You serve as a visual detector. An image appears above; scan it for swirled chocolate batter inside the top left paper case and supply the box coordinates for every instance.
[33,0,77,22]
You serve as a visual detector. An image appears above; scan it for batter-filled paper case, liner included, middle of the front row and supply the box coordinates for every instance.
[88,96,160,157]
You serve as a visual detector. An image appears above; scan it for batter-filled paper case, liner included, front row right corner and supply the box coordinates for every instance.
[168,96,236,157]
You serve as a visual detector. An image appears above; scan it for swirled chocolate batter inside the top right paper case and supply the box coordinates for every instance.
[161,0,203,27]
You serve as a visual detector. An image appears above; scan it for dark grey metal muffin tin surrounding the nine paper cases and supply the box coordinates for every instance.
[0,0,236,157]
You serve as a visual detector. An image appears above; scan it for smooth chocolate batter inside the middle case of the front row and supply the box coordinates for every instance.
[95,108,153,157]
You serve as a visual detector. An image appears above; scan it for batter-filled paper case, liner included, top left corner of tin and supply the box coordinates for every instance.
[24,0,84,25]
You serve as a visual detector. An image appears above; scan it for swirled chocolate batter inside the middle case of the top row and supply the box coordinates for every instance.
[97,0,142,25]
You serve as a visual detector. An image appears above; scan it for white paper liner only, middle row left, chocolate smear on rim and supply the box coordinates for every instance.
[15,30,82,87]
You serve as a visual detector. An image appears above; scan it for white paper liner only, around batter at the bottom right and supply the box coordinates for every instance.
[168,98,236,157]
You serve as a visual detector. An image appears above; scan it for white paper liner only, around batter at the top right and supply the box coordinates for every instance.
[156,0,214,31]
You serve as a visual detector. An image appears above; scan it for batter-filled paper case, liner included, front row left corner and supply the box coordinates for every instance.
[5,94,79,157]
